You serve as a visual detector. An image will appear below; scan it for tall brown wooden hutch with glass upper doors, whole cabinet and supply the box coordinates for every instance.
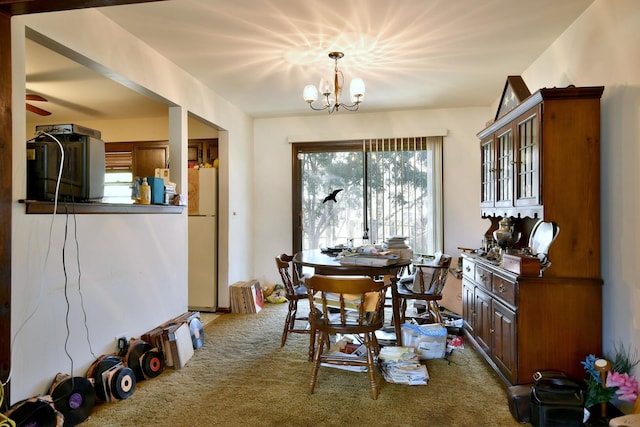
[462,78,604,385]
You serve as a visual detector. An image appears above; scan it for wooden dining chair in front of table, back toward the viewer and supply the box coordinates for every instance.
[305,274,388,399]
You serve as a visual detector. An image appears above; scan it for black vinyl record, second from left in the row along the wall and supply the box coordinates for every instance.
[49,374,96,427]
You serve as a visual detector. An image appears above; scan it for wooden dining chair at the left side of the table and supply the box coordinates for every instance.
[276,254,315,360]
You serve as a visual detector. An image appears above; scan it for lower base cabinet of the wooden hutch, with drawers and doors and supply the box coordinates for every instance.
[462,254,602,385]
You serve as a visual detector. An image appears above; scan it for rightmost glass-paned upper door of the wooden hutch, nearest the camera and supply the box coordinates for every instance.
[515,111,540,206]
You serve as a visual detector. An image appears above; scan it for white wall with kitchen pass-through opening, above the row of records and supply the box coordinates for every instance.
[11,9,253,403]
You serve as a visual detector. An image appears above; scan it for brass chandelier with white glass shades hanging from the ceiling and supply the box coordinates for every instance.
[303,52,364,114]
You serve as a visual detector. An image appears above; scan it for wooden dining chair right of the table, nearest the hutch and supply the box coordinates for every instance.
[394,255,451,323]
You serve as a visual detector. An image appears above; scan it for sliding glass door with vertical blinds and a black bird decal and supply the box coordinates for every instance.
[293,138,442,253]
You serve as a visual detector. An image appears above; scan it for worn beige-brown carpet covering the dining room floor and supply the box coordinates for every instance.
[82,304,520,427]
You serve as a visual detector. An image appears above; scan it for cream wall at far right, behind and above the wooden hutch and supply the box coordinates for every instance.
[523,0,640,362]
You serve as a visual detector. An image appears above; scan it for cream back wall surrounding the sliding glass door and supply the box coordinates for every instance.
[253,108,493,283]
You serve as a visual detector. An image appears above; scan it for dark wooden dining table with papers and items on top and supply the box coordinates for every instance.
[293,249,411,346]
